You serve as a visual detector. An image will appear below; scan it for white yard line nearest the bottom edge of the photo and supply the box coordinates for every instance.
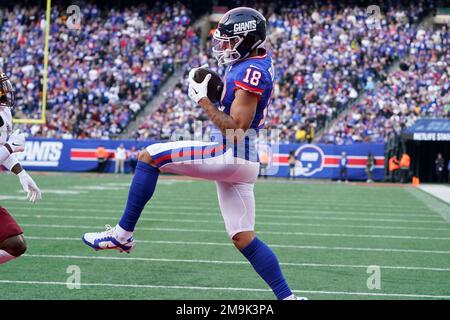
[0,280,450,299]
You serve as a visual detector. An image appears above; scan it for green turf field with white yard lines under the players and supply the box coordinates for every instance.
[0,174,450,299]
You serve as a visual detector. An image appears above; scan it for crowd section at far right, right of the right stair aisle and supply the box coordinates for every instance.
[323,27,450,144]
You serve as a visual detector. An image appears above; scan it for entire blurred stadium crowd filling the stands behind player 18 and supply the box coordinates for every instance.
[0,0,450,144]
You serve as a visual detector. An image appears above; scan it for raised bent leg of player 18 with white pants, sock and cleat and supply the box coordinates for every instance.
[82,141,251,252]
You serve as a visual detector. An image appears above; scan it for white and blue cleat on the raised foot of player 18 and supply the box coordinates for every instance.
[81,225,135,253]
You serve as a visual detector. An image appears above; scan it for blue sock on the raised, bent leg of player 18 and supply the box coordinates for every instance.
[119,161,159,231]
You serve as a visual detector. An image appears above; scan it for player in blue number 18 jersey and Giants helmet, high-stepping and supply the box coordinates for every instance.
[82,7,306,300]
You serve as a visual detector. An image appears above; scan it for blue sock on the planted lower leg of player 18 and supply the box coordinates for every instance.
[241,237,292,300]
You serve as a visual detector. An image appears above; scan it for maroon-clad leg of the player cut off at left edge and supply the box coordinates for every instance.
[0,207,27,264]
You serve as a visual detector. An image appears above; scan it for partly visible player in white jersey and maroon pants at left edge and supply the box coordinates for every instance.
[0,73,41,264]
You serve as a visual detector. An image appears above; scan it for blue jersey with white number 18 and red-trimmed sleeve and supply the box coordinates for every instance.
[220,52,275,131]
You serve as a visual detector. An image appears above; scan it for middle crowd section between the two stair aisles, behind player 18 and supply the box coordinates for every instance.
[134,2,436,141]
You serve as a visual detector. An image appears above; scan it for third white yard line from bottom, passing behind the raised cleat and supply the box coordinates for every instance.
[27,236,450,254]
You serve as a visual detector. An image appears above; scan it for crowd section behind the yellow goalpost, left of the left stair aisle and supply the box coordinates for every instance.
[0,3,198,138]
